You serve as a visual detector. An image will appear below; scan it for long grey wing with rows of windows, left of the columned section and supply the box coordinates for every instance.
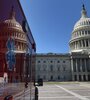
[36,53,71,81]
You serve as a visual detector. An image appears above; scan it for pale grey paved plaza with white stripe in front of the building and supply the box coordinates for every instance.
[38,82,90,100]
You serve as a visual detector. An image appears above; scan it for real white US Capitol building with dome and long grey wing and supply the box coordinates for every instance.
[36,5,90,81]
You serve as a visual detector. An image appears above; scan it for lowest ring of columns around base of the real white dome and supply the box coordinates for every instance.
[70,39,90,50]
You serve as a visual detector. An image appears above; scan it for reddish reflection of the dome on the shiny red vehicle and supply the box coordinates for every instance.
[0,7,27,53]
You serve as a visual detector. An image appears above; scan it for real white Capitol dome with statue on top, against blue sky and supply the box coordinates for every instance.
[69,5,90,53]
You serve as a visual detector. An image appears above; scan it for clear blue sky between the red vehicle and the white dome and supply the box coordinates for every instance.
[21,0,90,53]
